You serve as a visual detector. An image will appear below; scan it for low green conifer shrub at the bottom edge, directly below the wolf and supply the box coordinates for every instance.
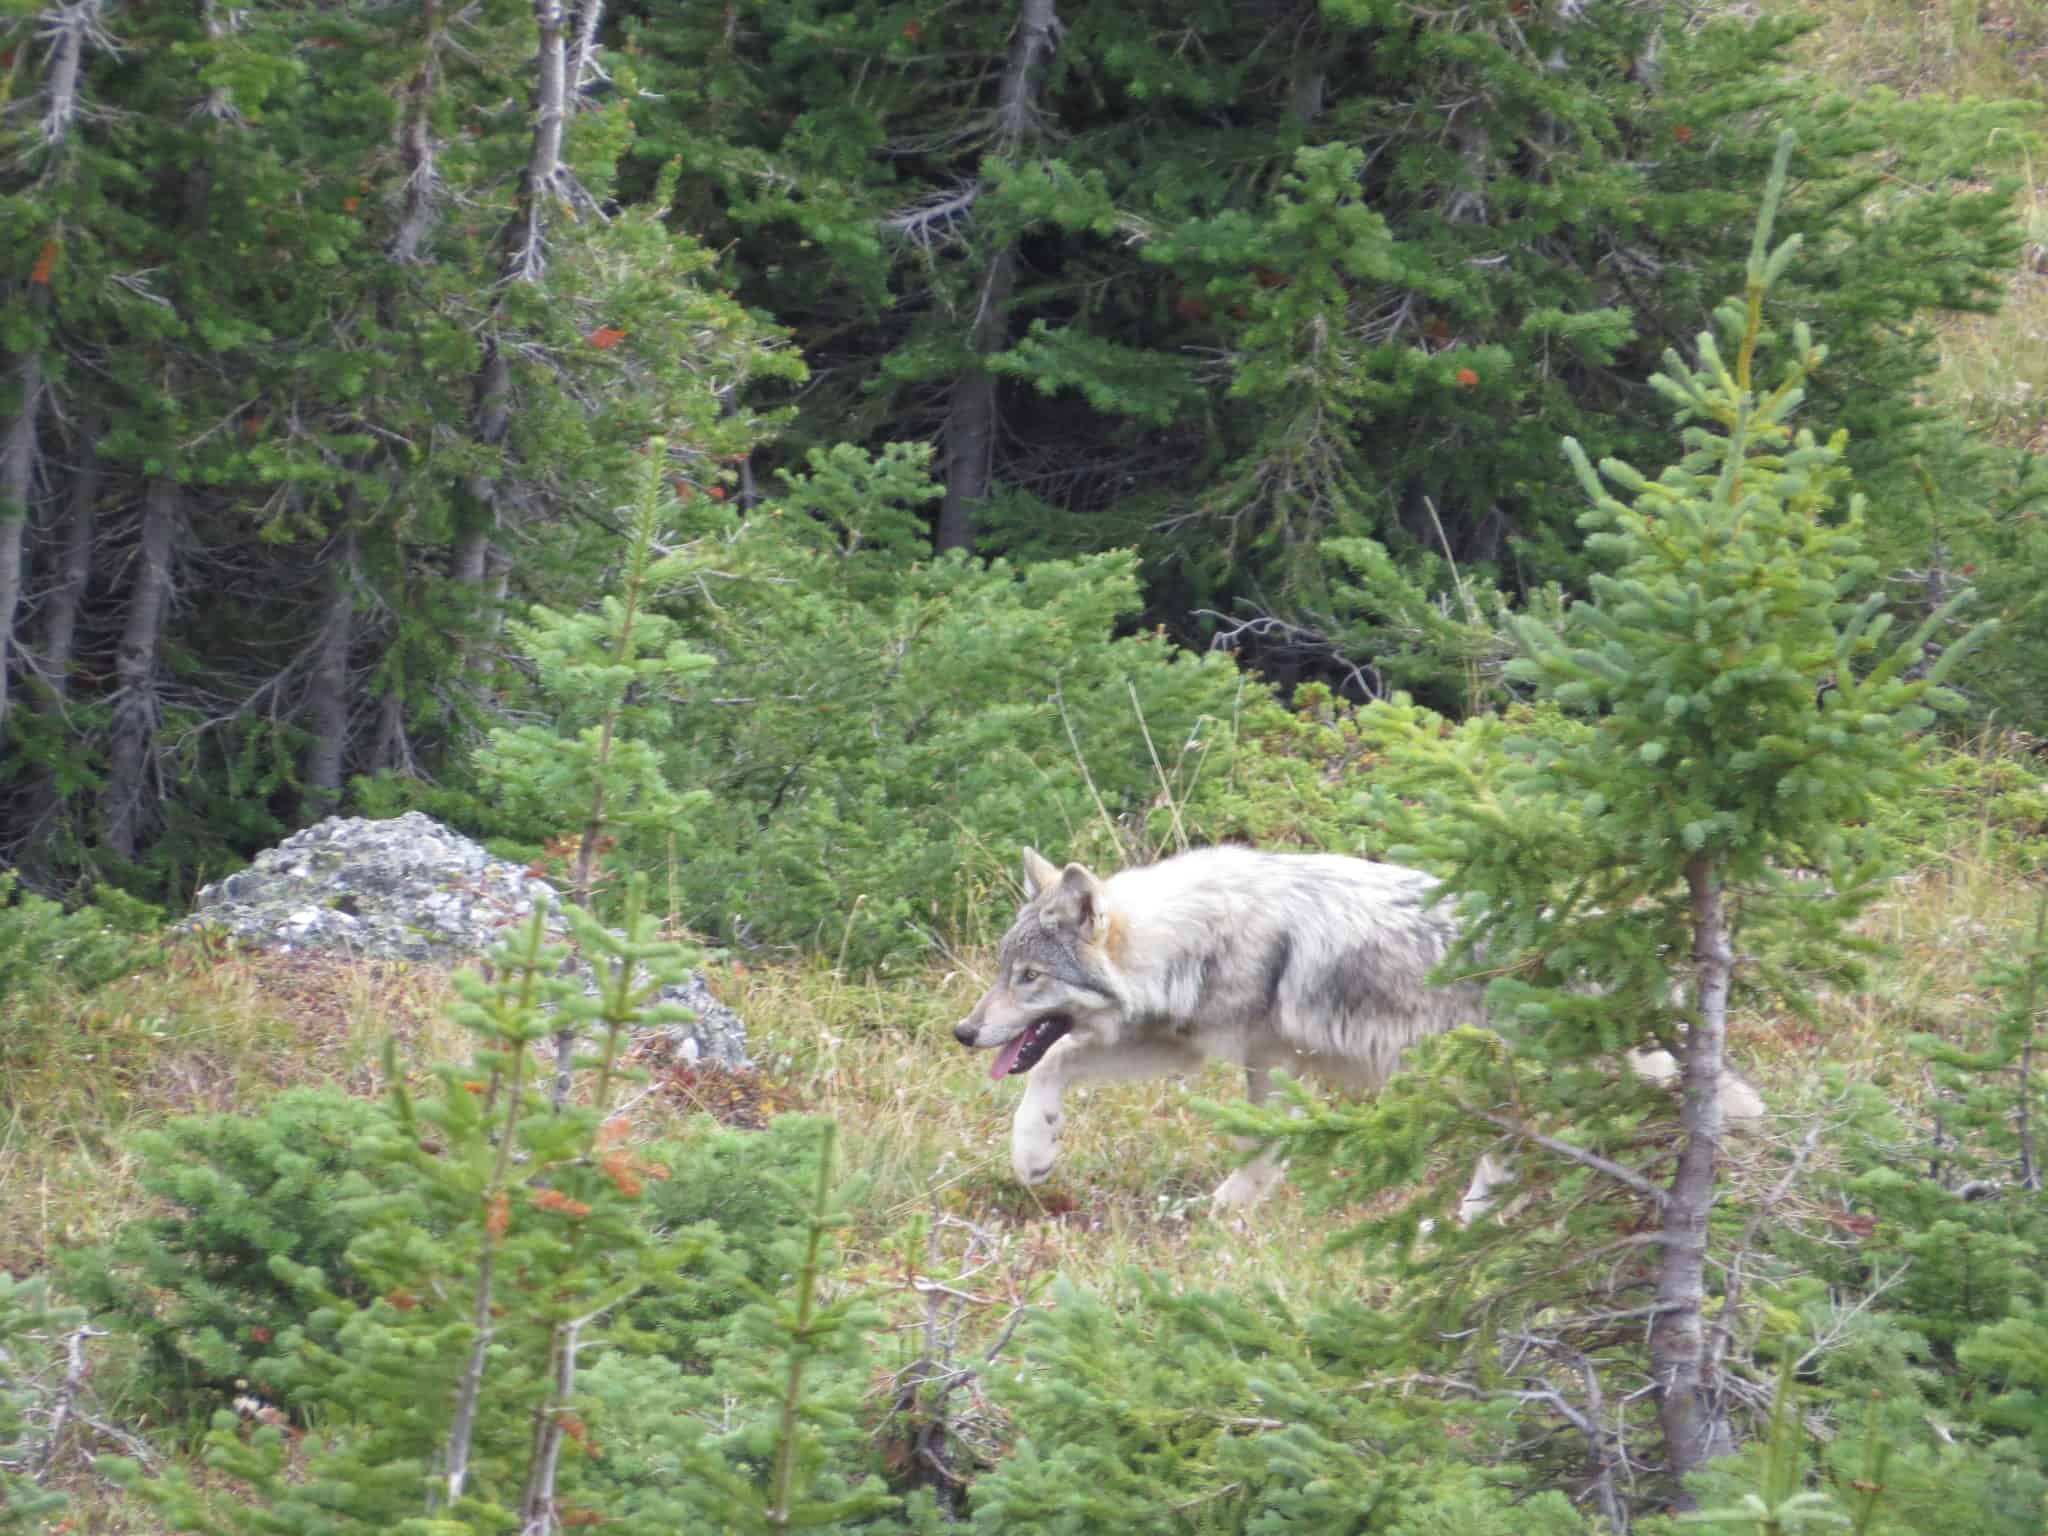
[973,1280,1591,1536]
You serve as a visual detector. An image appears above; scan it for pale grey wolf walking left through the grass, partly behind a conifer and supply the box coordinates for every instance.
[952,848,1763,1221]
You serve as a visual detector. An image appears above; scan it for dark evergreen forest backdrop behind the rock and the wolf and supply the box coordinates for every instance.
[0,0,2040,933]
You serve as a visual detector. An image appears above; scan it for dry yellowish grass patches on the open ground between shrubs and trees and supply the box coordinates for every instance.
[16,0,2048,1532]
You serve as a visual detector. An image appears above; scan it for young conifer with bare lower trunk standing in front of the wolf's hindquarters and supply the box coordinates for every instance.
[1239,137,1982,1524]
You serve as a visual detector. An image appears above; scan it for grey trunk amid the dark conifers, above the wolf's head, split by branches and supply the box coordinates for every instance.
[936,0,1059,553]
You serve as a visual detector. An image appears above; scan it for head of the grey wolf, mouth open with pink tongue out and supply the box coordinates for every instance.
[952,848,1122,1077]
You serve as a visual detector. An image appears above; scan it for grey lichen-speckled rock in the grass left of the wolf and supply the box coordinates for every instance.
[180,811,748,1067]
